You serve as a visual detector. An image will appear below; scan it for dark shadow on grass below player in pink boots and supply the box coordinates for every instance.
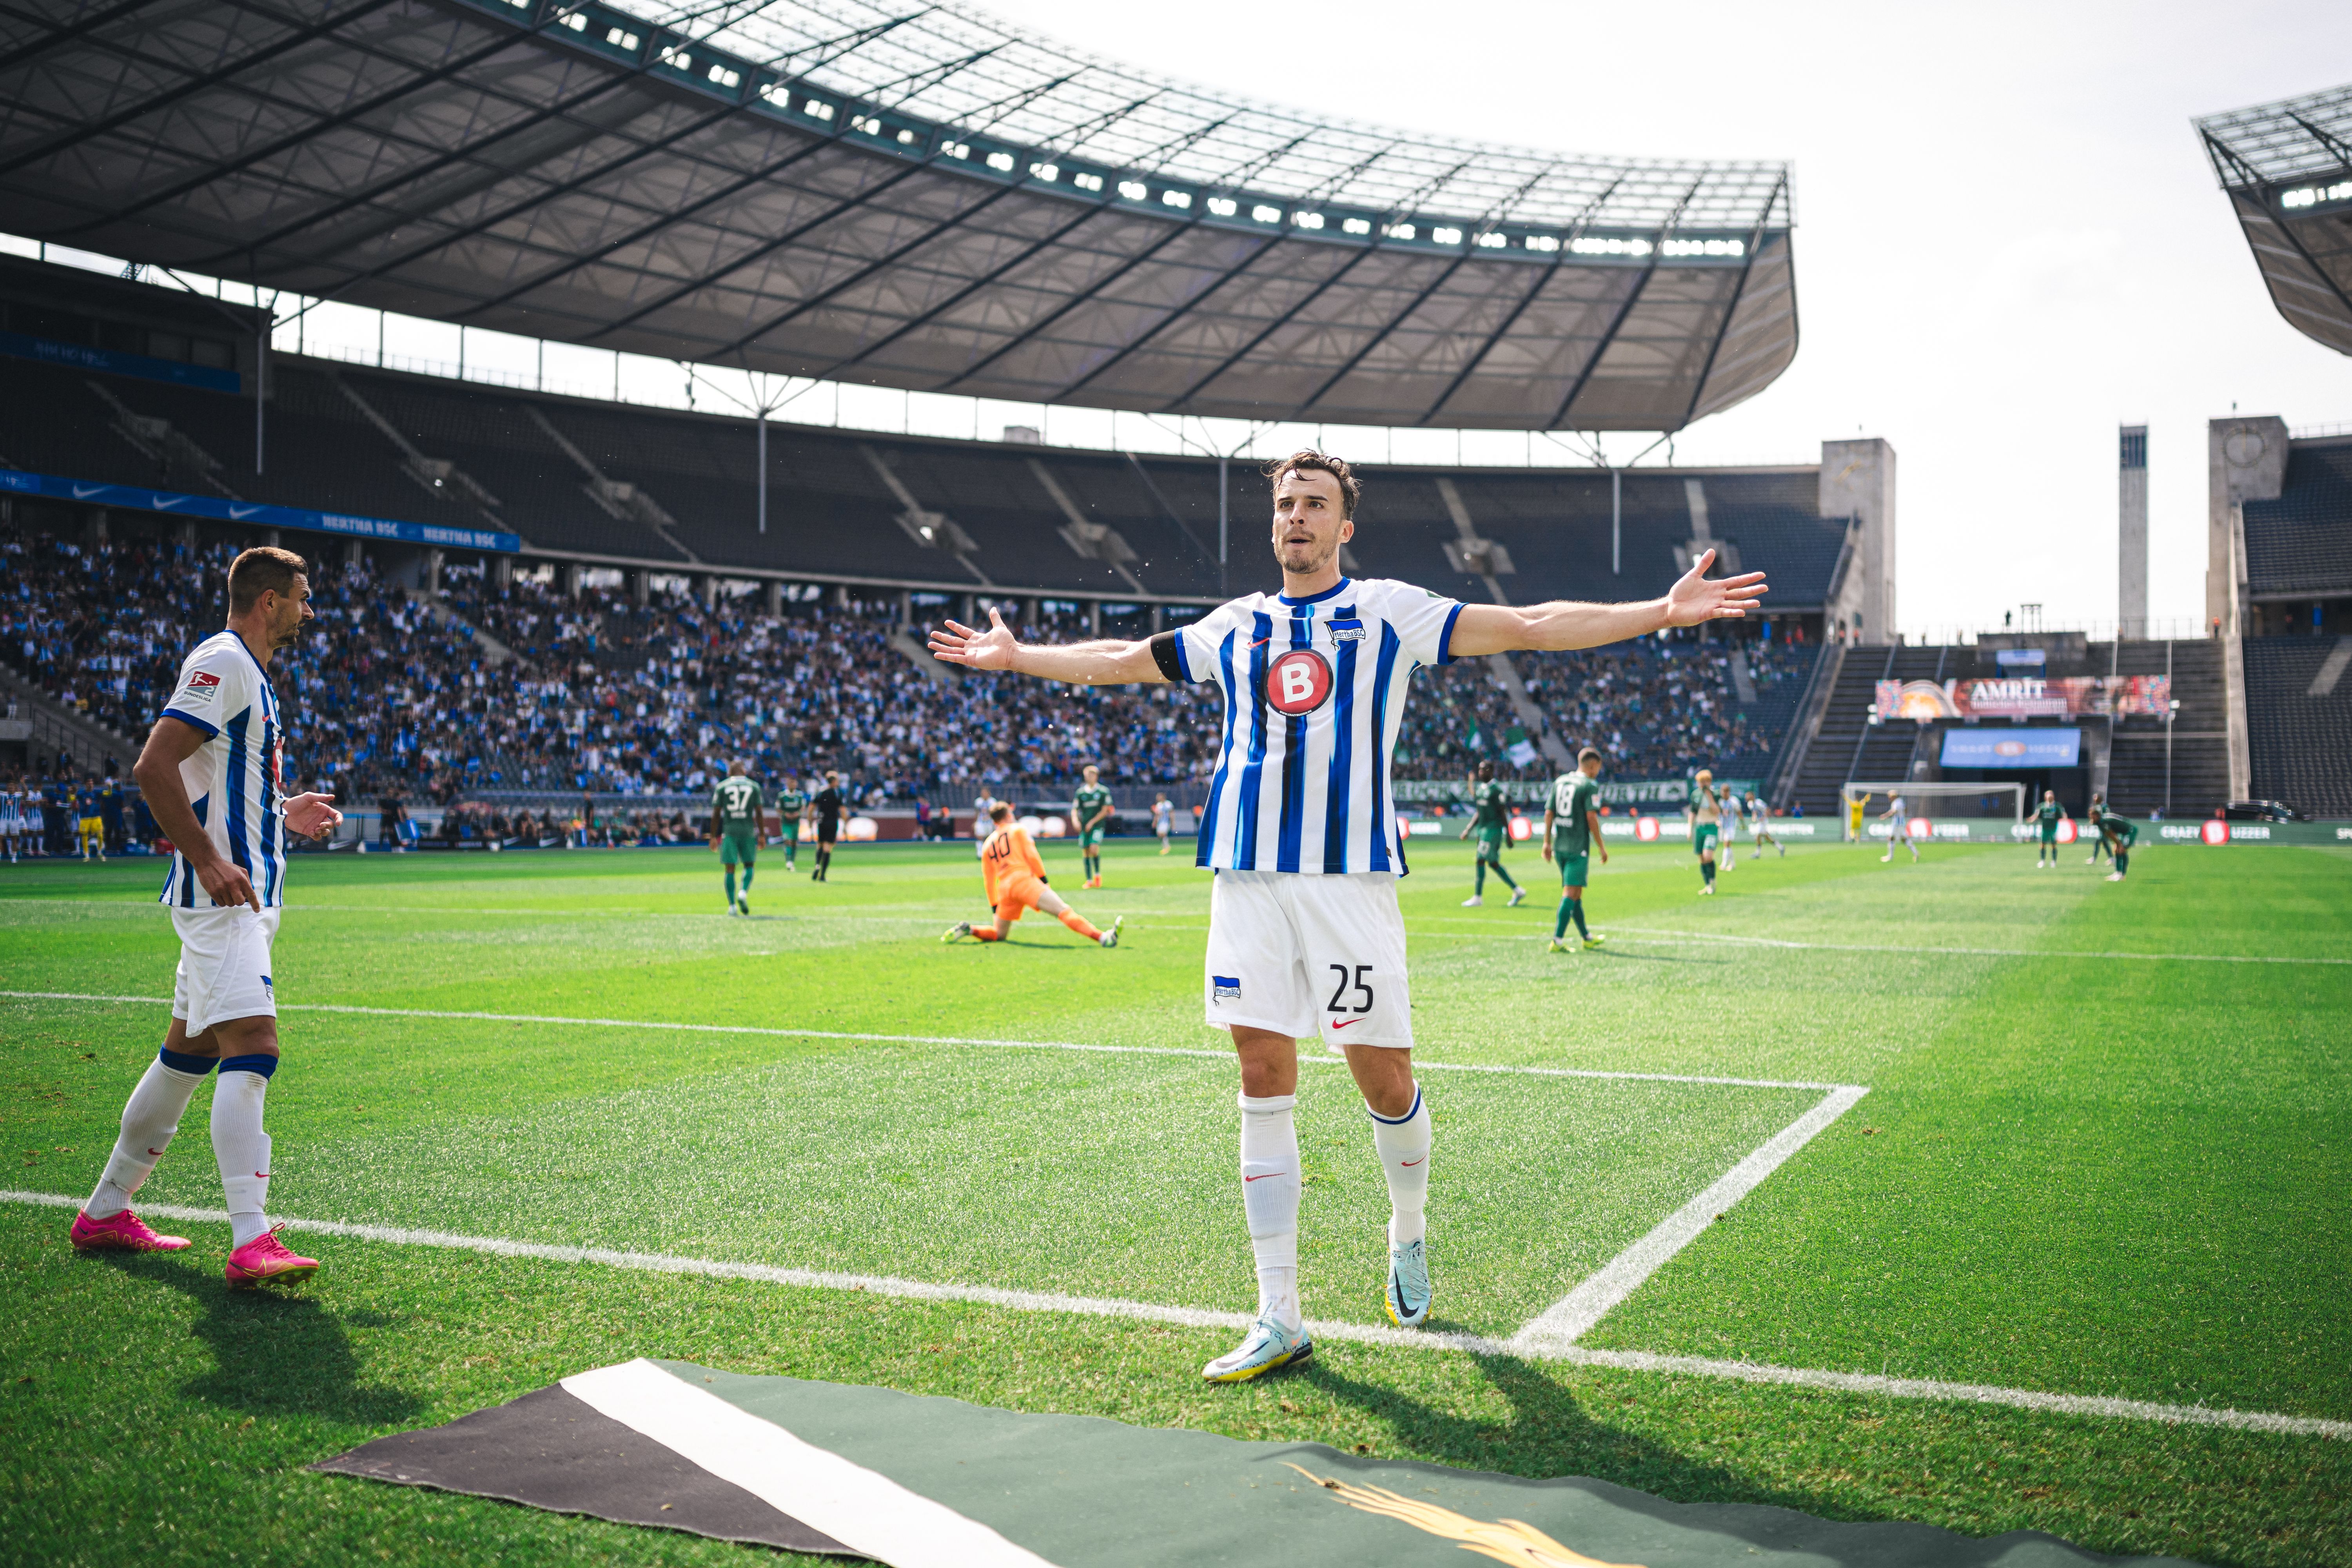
[108,1253,426,1427]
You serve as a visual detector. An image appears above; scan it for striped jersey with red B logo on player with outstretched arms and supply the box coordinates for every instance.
[1176,578,1463,875]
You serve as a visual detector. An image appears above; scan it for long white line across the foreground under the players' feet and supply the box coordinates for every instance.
[0,1192,2352,1441]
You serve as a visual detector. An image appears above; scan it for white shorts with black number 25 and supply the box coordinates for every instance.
[1202,872,1414,1049]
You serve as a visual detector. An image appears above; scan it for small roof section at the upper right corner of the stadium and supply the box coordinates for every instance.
[2197,87,2352,355]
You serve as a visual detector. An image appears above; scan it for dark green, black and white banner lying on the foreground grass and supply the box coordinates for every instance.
[313,1361,2171,1568]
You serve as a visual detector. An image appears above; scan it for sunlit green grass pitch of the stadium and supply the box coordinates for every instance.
[0,842,2352,1563]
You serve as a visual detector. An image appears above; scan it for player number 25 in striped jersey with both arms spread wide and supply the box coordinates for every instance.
[931,451,1764,1382]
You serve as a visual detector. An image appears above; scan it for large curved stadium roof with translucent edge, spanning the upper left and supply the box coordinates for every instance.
[0,0,1797,430]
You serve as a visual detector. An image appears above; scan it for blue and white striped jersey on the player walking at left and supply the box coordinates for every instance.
[162,632,287,910]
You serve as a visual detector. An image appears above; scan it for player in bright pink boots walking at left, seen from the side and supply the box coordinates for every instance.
[71,548,343,1286]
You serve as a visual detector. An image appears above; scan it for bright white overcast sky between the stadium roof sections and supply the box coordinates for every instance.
[988,0,2352,630]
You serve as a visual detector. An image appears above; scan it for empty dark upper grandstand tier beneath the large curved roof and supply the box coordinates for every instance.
[0,245,1853,635]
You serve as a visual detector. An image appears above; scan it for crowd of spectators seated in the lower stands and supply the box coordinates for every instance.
[0,526,1813,808]
